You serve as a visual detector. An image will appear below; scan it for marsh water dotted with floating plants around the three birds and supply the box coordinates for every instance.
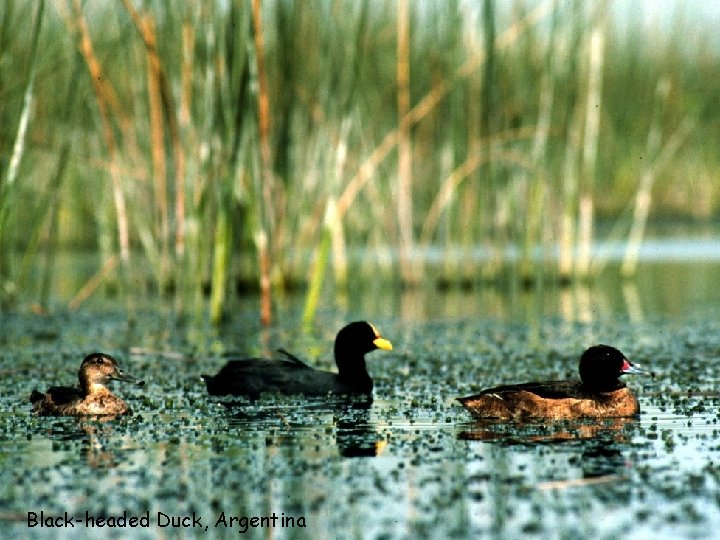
[0,252,720,539]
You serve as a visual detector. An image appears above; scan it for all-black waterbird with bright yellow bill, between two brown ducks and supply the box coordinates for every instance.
[202,321,392,397]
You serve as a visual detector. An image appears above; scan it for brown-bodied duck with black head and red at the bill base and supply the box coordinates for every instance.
[458,345,654,419]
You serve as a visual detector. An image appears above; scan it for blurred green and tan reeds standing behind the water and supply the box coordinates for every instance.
[0,0,720,321]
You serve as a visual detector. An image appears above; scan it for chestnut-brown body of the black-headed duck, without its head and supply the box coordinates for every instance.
[458,381,640,419]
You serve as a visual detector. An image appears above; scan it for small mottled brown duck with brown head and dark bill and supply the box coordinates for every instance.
[30,353,145,416]
